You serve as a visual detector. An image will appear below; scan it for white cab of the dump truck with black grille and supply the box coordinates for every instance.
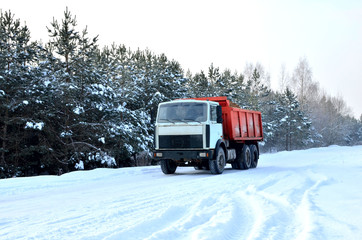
[154,99,223,174]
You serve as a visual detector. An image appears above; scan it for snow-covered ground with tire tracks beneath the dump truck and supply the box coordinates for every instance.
[0,146,362,240]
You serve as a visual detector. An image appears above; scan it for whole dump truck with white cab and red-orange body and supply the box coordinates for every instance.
[153,97,263,174]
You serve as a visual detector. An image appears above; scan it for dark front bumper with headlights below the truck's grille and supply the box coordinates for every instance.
[153,150,214,162]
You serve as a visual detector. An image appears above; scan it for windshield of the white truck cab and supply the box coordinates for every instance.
[157,102,207,123]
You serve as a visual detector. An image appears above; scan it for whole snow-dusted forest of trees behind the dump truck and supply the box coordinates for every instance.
[0,9,362,178]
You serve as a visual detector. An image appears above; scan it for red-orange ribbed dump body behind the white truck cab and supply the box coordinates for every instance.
[194,97,263,142]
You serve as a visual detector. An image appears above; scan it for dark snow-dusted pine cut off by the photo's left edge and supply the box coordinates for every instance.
[0,11,43,177]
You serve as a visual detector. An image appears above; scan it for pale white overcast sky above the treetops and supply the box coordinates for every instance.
[0,0,362,117]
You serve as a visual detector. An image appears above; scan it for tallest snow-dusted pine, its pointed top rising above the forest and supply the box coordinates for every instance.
[45,9,117,172]
